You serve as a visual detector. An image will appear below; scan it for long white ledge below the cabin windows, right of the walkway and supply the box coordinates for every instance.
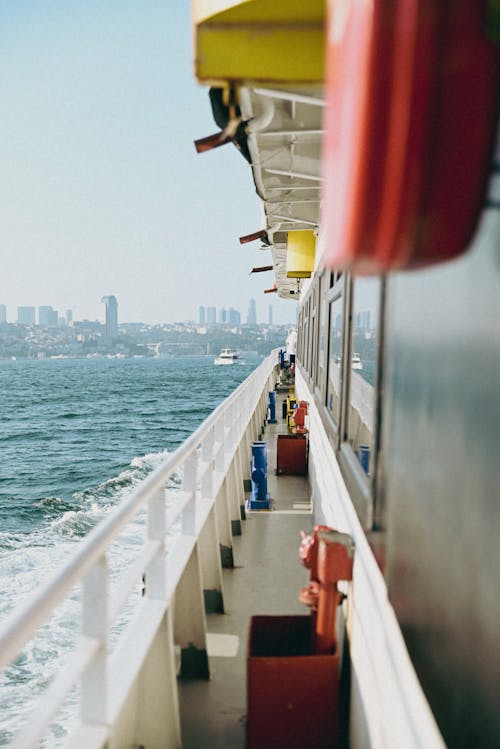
[295,371,444,749]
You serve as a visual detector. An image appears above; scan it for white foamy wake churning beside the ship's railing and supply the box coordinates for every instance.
[0,450,180,747]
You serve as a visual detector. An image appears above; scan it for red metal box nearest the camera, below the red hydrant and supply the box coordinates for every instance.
[247,616,339,749]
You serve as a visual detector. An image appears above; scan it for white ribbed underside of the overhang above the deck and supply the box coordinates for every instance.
[239,86,323,299]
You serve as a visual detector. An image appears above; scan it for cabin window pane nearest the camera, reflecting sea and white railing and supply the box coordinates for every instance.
[347,278,381,475]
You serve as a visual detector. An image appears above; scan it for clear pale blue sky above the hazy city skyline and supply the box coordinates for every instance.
[0,0,296,323]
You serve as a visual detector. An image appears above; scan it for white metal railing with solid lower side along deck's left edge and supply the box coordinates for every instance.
[0,352,277,749]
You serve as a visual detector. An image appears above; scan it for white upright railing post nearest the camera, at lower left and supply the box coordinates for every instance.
[81,554,108,725]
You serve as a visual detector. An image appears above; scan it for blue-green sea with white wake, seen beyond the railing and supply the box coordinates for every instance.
[0,357,256,746]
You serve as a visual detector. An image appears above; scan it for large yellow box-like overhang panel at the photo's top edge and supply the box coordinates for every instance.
[193,0,325,86]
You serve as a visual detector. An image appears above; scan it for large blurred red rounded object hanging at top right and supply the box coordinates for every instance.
[322,0,500,273]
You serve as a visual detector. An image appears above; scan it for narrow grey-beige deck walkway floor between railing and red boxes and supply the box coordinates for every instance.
[179,423,312,749]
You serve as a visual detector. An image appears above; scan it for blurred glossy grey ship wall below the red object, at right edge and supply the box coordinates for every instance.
[381,202,500,747]
